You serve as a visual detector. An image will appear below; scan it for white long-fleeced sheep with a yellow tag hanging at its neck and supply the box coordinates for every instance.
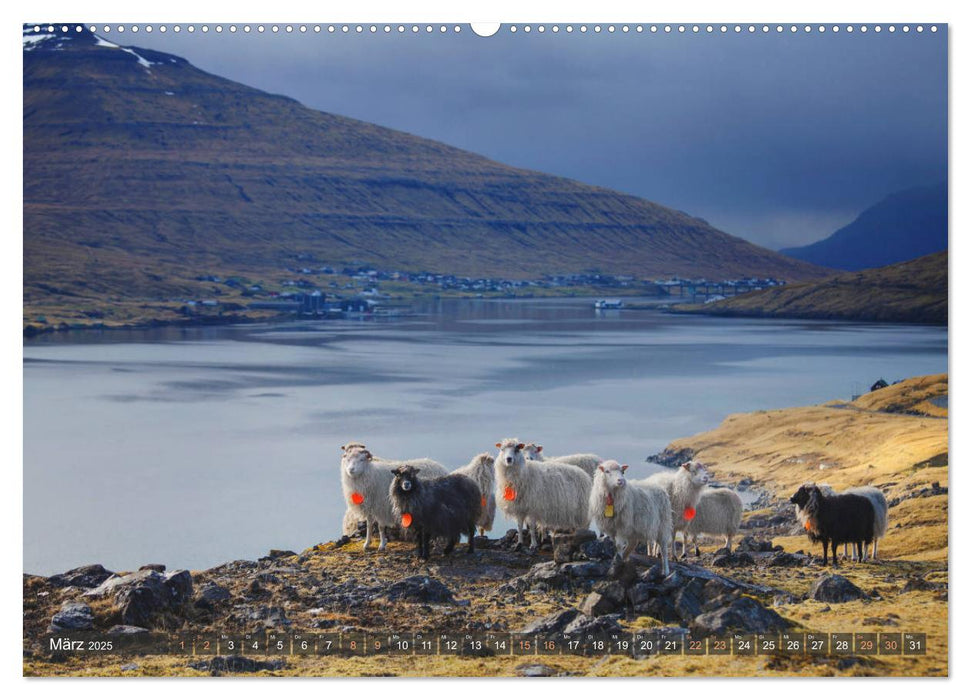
[589,459,671,576]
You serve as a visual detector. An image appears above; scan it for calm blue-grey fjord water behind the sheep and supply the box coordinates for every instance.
[24,299,947,574]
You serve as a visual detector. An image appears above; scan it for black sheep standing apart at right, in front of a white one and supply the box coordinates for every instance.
[789,485,873,567]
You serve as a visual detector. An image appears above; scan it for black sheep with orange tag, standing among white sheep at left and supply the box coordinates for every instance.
[389,465,482,559]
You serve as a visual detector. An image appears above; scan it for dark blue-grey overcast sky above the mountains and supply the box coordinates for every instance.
[123,26,947,248]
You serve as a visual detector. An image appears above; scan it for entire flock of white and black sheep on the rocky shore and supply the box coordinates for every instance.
[341,438,887,574]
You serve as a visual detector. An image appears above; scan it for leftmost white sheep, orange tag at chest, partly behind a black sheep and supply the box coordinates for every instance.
[341,444,448,551]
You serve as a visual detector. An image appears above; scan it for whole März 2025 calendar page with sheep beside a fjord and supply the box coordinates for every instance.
[22,23,950,678]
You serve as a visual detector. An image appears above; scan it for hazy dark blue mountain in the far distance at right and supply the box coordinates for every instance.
[779,182,947,270]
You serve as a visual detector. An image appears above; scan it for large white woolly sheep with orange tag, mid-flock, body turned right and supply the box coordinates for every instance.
[495,438,591,549]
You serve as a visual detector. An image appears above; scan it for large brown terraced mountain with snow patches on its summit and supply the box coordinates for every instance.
[23,25,825,318]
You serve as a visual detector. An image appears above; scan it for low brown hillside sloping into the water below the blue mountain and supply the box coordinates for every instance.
[676,251,947,325]
